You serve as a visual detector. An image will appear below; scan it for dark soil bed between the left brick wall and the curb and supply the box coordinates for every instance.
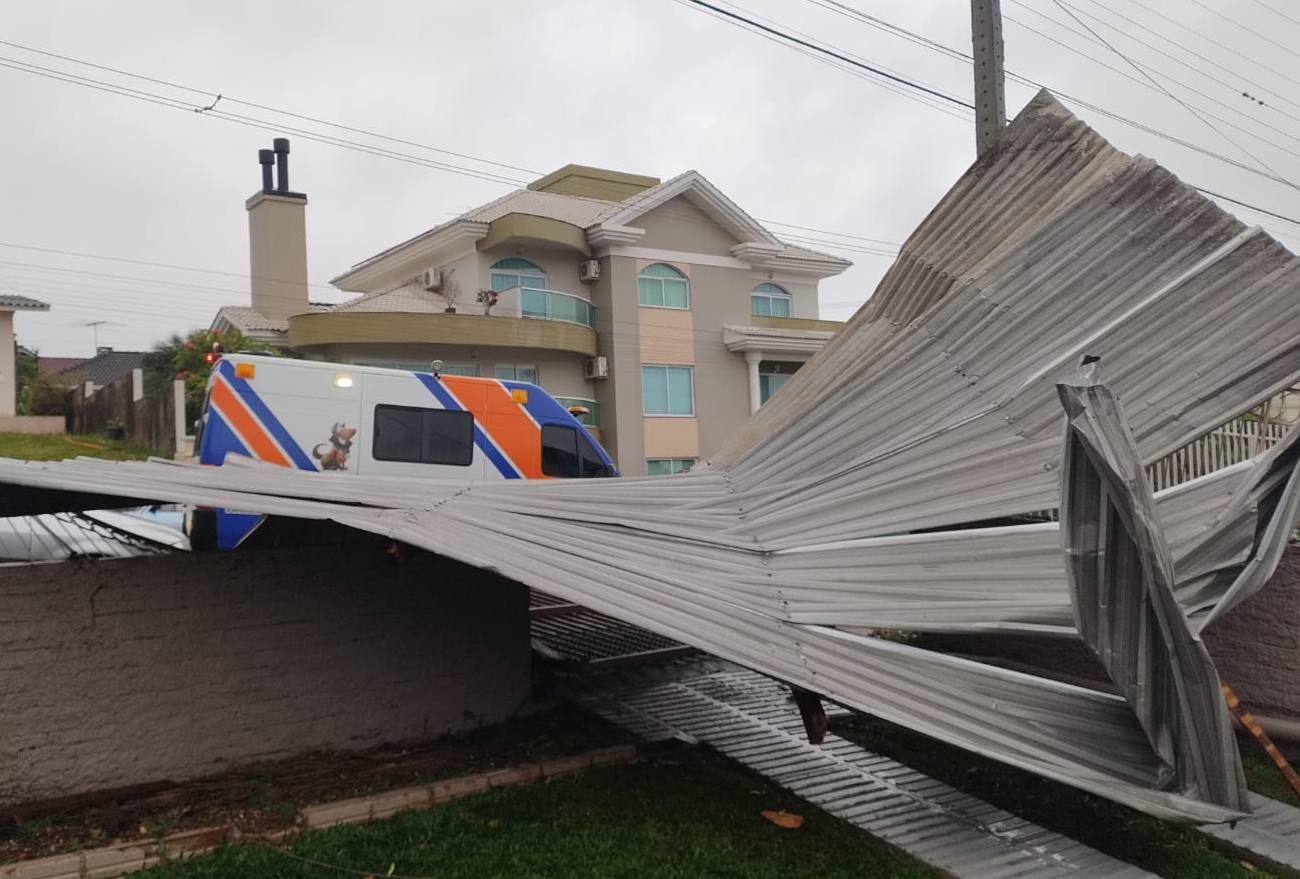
[0,705,633,863]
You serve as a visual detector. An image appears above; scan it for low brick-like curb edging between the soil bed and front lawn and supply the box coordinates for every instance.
[0,745,644,879]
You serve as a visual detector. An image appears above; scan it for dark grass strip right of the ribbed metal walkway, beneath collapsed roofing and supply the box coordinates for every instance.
[835,718,1286,879]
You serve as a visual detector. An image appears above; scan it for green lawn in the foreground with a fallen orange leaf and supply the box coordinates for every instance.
[142,749,940,879]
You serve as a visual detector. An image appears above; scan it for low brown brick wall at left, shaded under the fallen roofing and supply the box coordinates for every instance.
[0,545,529,804]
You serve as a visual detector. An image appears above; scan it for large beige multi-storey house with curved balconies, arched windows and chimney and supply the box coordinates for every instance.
[213,144,850,475]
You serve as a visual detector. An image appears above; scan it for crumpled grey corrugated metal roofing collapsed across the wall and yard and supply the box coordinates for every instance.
[0,94,1300,823]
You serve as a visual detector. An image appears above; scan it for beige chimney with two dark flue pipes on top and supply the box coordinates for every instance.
[244,138,307,320]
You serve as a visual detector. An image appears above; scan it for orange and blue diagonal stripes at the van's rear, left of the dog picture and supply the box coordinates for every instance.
[199,360,316,471]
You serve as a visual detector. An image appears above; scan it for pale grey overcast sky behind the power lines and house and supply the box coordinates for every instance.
[0,0,1300,356]
